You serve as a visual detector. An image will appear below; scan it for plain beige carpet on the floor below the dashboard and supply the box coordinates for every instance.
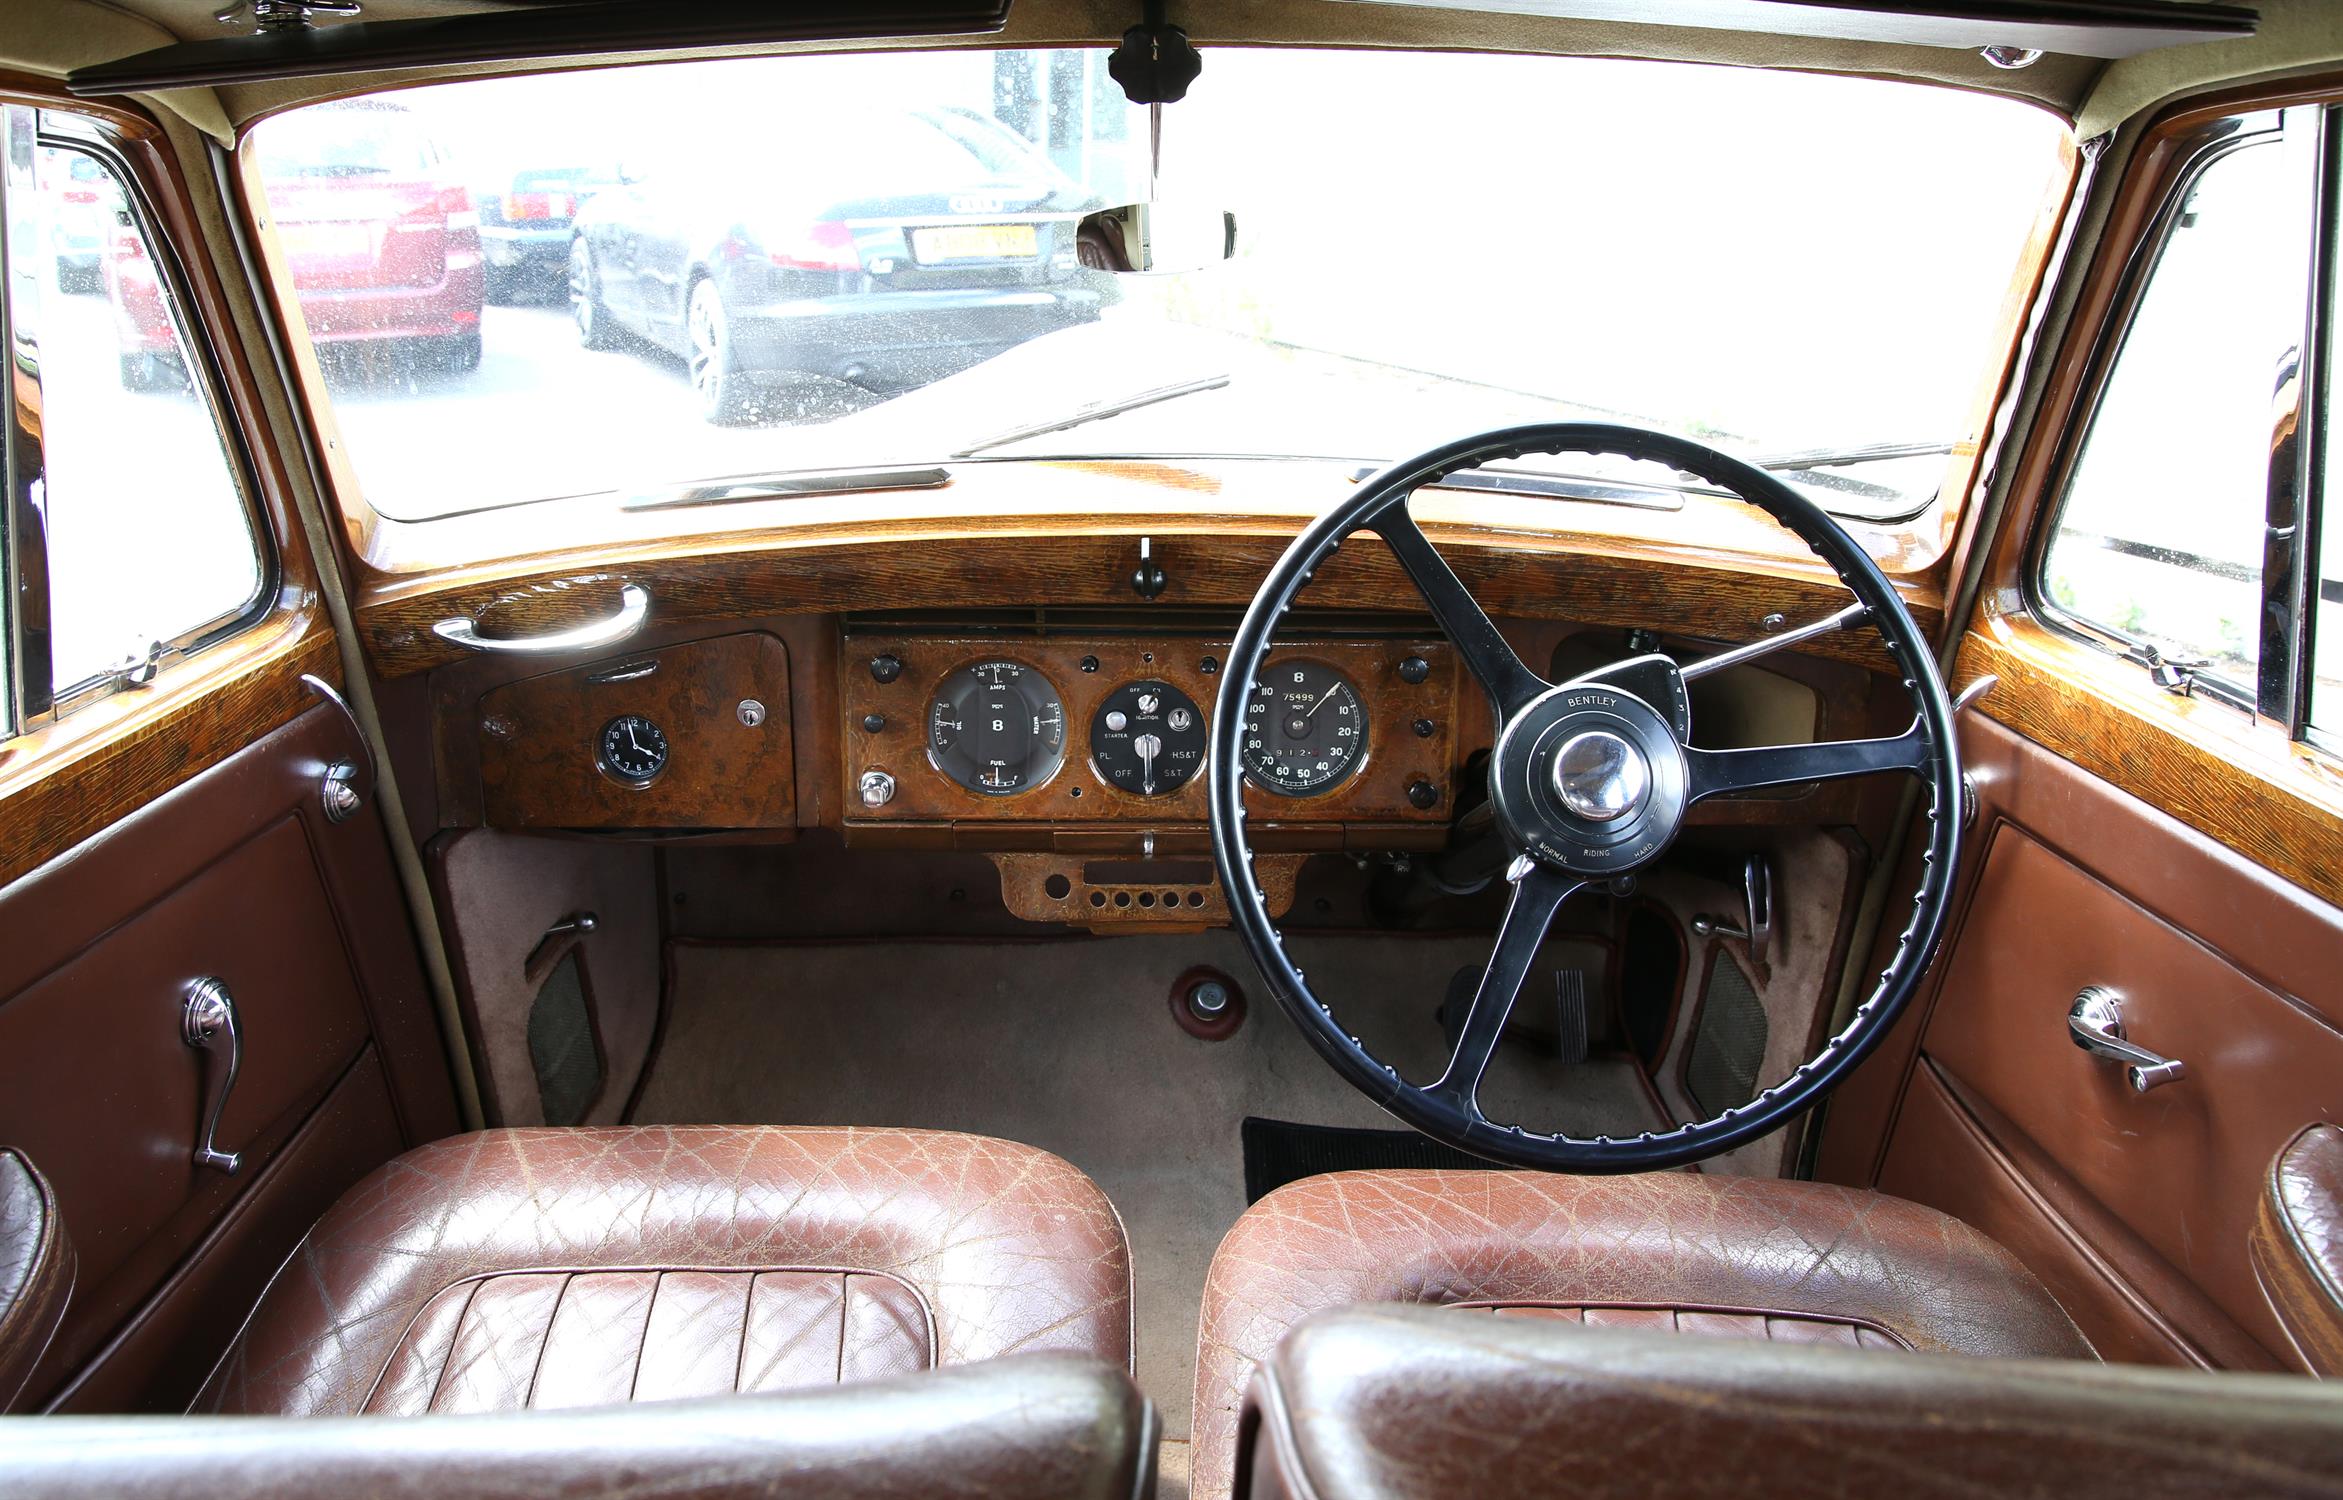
[635,933,1659,1439]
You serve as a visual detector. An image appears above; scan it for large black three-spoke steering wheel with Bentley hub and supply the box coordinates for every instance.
[1207,422,1961,1172]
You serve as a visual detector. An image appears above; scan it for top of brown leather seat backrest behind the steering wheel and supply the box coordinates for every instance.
[1242,1308,2343,1500]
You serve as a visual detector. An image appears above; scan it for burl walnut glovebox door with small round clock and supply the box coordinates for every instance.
[478,633,797,830]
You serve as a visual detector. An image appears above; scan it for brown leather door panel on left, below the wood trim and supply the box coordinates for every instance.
[0,708,452,1404]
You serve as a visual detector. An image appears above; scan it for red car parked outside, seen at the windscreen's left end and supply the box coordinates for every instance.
[105,101,487,387]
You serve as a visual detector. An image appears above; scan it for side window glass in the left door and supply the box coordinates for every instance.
[5,105,265,726]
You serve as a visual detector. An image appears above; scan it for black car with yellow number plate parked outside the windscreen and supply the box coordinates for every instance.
[569,108,1113,422]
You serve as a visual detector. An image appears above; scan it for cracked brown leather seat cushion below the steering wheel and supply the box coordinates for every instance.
[1190,1172,2092,1500]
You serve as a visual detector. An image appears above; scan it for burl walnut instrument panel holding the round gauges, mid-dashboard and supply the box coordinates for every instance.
[839,633,1460,851]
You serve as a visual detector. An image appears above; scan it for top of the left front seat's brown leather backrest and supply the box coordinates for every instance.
[0,1355,1155,1500]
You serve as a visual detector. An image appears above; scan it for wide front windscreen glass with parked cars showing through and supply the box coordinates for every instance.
[248,49,2069,525]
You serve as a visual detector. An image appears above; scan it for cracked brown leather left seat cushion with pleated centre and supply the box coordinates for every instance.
[197,1127,1132,1416]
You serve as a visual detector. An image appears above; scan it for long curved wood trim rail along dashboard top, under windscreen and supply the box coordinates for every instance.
[342,502,1942,677]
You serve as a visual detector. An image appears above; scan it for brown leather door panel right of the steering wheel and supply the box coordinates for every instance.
[1856,720,2343,1366]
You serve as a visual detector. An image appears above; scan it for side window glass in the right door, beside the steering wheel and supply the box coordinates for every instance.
[2041,110,2331,705]
